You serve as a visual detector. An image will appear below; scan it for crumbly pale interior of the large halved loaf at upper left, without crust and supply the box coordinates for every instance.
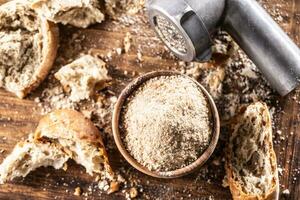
[0,1,43,96]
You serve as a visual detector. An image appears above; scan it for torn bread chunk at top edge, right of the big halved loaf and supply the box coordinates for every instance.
[31,0,104,28]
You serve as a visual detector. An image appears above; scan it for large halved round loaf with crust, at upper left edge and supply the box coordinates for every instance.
[0,0,58,98]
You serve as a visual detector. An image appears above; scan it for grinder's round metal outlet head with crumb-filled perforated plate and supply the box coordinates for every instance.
[148,0,212,61]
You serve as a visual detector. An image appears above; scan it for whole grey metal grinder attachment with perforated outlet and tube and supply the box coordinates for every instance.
[147,0,300,95]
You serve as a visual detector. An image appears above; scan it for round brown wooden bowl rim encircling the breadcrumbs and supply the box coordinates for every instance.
[112,71,220,178]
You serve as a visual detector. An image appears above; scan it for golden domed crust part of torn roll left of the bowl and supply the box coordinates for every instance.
[35,110,112,175]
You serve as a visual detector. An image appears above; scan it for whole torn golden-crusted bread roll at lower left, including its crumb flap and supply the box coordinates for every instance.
[0,110,114,184]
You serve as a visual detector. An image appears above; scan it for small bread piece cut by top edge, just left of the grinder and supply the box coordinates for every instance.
[105,0,145,18]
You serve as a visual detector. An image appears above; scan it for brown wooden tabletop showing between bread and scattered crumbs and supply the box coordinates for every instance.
[0,0,300,200]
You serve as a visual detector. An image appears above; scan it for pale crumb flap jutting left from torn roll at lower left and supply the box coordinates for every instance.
[0,139,69,184]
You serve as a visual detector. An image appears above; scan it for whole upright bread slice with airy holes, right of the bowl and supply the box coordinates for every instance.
[226,102,279,200]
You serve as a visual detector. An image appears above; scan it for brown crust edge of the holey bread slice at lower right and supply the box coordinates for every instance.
[225,102,279,200]
